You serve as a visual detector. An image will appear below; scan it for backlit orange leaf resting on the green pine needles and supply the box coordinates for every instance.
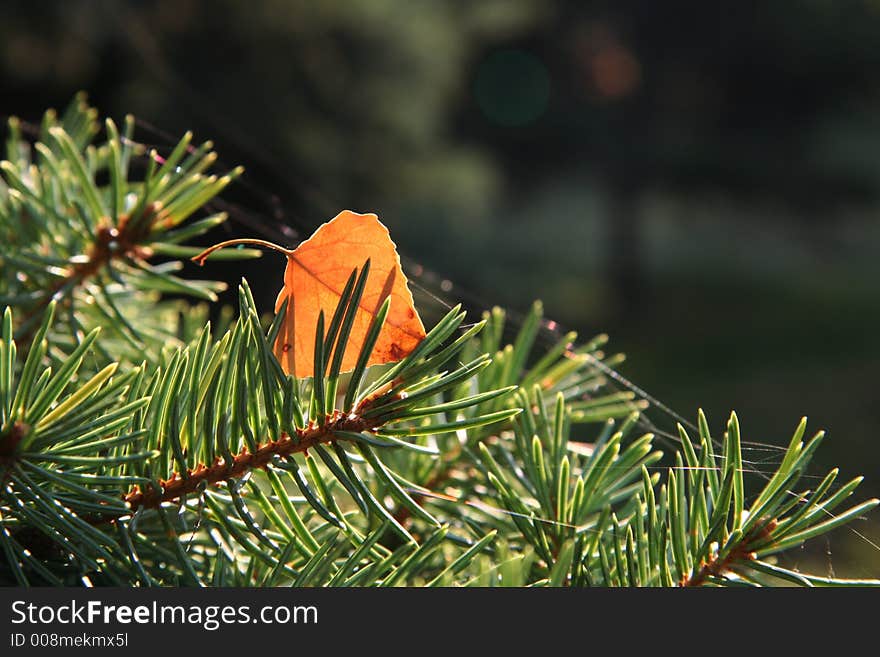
[274,210,425,377]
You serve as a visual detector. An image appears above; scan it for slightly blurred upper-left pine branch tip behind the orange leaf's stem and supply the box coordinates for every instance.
[0,95,260,362]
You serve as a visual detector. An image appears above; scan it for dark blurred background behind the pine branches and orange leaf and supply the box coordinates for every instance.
[0,0,880,577]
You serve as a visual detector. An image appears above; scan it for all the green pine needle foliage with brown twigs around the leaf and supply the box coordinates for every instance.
[0,99,877,586]
